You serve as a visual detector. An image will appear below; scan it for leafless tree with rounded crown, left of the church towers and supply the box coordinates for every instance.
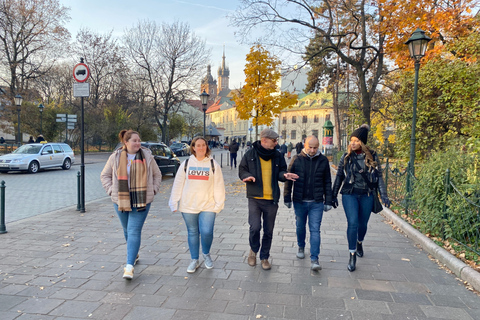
[124,21,210,142]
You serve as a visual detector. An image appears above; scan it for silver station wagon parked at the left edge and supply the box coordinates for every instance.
[0,142,75,173]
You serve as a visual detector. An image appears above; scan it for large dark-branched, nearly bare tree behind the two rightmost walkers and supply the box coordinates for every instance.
[233,0,385,123]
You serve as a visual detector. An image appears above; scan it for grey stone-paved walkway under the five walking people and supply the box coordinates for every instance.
[0,159,480,320]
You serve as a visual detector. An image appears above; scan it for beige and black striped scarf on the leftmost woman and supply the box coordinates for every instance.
[117,148,147,211]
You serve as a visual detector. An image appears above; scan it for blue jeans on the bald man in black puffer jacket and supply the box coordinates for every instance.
[293,202,323,260]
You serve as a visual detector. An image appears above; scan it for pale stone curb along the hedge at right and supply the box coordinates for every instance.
[330,167,480,291]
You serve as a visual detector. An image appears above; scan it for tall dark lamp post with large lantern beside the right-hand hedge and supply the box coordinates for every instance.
[405,29,432,176]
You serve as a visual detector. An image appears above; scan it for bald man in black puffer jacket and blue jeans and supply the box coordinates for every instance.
[283,136,332,271]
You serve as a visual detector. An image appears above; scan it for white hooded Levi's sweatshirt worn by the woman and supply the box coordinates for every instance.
[168,155,225,213]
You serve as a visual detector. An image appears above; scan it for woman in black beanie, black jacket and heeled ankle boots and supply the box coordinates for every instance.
[332,124,390,272]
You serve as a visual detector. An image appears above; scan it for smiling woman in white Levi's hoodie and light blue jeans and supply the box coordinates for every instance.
[169,137,225,273]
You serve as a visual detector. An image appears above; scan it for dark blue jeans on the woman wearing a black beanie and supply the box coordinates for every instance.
[342,194,373,251]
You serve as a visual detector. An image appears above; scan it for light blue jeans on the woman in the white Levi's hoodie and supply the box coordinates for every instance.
[182,211,216,259]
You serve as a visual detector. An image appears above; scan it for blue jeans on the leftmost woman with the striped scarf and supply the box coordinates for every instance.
[113,203,150,265]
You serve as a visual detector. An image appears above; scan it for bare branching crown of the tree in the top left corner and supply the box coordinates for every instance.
[0,0,70,96]
